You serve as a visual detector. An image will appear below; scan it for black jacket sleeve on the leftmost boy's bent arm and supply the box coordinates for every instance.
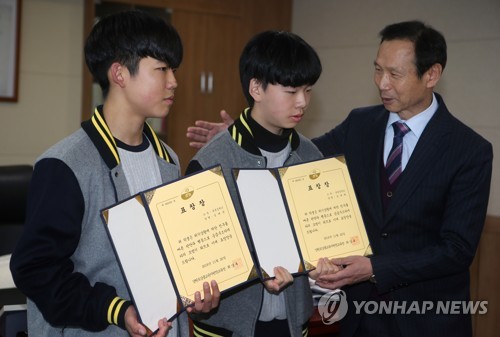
[11,159,125,331]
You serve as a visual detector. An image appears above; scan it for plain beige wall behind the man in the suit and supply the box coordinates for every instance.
[292,0,500,215]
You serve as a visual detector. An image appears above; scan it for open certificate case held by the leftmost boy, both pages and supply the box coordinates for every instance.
[102,166,258,331]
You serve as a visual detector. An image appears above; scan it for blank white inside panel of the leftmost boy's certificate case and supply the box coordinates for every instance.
[100,196,178,331]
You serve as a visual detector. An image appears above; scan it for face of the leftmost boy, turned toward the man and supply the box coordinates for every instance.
[125,57,177,118]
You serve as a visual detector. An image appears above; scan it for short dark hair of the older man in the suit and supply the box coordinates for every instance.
[379,20,447,78]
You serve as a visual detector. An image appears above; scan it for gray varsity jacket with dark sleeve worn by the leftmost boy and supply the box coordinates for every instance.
[11,111,188,337]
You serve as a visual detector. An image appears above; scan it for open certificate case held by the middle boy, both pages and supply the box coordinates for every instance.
[233,156,371,273]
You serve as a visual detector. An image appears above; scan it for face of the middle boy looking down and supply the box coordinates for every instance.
[249,79,312,135]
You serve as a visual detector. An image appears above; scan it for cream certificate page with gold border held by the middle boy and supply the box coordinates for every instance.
[278,156,371,266]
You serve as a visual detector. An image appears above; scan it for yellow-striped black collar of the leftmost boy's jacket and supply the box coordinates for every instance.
[82,105,175,169]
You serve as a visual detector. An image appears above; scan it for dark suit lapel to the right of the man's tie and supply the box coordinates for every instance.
[385,100,451,224]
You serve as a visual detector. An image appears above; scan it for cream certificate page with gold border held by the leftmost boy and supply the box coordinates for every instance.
[146,167,254,304]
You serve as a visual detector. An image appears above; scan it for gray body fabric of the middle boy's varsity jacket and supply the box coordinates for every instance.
[191,132,323,337]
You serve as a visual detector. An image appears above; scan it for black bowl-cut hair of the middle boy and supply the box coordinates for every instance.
[240,30,322,107]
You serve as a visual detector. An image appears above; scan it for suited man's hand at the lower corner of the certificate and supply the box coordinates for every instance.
[316,256,373,289]
